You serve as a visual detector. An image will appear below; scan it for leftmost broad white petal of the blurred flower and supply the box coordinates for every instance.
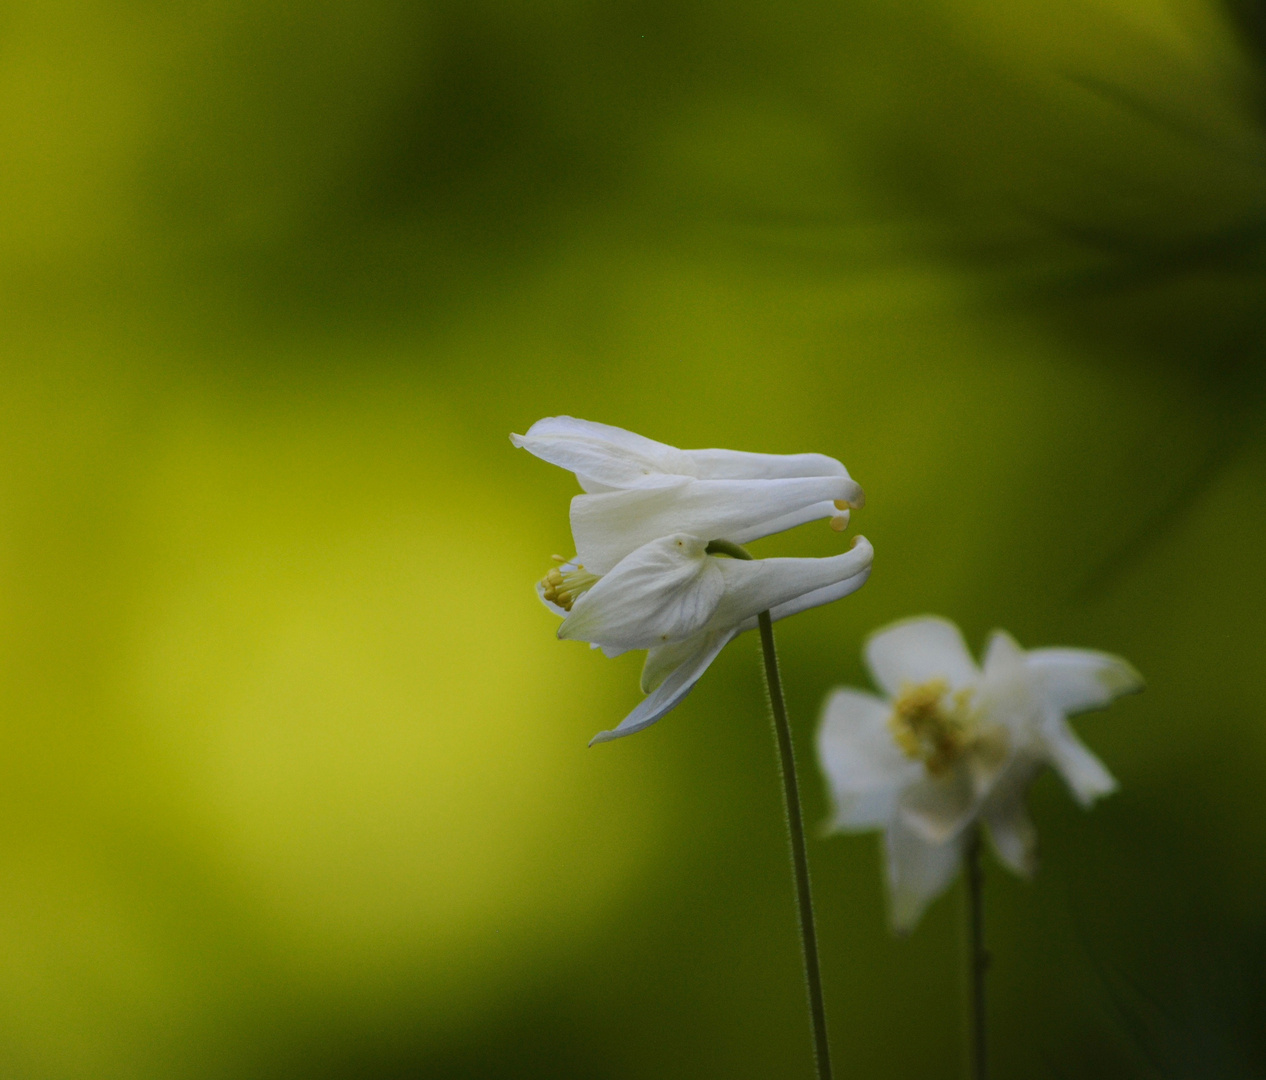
[818,688,923,829]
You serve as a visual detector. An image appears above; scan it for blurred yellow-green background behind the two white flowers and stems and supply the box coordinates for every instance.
[0,0,1266,1080]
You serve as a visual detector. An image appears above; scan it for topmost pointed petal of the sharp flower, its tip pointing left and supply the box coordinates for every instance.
[510,417,693,491]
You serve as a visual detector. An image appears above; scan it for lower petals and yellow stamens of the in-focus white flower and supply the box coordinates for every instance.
[539,533,874,744]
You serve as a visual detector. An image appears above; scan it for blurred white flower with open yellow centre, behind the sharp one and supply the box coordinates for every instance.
[818,615,1143,932]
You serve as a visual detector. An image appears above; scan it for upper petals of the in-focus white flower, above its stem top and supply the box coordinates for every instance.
[510,417,865,575]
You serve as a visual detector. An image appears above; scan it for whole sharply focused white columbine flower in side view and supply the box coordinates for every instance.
[510,417,874,742]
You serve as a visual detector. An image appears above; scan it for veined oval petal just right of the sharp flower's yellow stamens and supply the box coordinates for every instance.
[558,534,725,656]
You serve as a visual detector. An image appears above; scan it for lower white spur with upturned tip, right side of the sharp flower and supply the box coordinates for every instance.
[715,538,875,627]
